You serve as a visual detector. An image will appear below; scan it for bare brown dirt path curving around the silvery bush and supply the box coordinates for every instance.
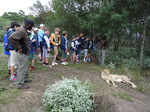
[0,64,150,112]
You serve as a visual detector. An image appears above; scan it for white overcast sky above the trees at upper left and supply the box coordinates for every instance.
[0,0,48,16]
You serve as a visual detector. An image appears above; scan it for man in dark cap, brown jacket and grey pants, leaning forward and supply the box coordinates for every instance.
[9,19,34,89]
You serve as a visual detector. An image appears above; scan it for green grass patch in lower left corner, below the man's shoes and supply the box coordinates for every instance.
[0,89,21,104]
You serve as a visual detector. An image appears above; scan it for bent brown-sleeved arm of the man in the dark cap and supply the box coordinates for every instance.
[9,30,25,51]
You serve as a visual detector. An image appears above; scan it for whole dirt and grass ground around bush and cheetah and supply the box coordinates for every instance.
[0,46,150,112]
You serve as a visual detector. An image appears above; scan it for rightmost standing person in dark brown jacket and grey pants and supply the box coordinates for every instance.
[97,36,108,65]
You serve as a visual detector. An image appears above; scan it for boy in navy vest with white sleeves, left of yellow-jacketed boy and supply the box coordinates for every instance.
[42,28,51,67]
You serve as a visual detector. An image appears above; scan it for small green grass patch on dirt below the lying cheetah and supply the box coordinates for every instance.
[112,92,132,101]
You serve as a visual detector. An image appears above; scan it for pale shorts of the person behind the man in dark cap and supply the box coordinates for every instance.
[9,50,17,66]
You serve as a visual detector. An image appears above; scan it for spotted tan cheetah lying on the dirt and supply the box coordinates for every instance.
[101,69,137,88]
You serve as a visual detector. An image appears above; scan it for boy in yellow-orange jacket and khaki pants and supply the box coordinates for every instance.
[50,28,60,66]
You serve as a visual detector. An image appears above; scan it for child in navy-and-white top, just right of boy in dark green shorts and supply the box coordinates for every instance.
[70,35,77,63]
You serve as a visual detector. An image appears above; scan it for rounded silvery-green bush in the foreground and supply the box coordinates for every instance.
[43,79,93,112]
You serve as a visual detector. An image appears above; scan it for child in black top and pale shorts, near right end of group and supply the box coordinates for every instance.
[83,37,89,62]
